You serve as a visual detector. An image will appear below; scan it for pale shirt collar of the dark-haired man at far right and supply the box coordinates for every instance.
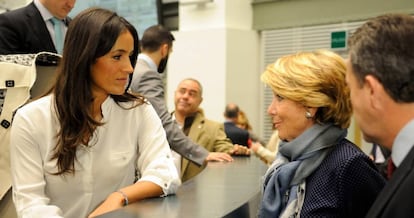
[391,119,414,167]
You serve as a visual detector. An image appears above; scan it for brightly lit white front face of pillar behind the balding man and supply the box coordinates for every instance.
[166,29,227,120]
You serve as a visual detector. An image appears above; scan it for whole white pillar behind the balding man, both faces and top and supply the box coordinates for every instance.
[166,0,260,133]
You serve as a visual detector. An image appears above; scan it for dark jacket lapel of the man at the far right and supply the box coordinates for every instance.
[367,147,414,217]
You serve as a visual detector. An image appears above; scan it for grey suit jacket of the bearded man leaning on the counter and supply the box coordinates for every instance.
[130,59,209,166]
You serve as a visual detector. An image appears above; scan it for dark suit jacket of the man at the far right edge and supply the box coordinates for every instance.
[367,147,414,218]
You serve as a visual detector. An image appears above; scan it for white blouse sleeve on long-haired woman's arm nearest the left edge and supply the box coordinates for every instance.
[10,108,63,217]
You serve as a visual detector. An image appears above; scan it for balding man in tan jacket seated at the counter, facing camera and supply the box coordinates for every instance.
[172,78,250,182]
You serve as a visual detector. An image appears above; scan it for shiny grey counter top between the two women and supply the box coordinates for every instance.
[99,156,267,218]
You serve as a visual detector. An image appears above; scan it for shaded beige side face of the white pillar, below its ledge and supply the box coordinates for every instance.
[226,29,262,131]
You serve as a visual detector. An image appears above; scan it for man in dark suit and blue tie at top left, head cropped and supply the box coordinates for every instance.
[0,0,76,54]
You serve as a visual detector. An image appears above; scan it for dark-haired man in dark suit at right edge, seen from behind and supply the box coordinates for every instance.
[346,14,414,218]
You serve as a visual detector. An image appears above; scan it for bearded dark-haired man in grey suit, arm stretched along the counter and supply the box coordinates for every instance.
[130,25,233,175]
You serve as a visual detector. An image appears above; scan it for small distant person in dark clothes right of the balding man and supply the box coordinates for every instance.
[224,103,250,147]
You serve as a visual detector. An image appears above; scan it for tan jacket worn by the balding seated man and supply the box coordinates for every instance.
[181,110,233,182]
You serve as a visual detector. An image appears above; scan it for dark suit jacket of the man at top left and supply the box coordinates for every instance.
[0,2,70,54]
